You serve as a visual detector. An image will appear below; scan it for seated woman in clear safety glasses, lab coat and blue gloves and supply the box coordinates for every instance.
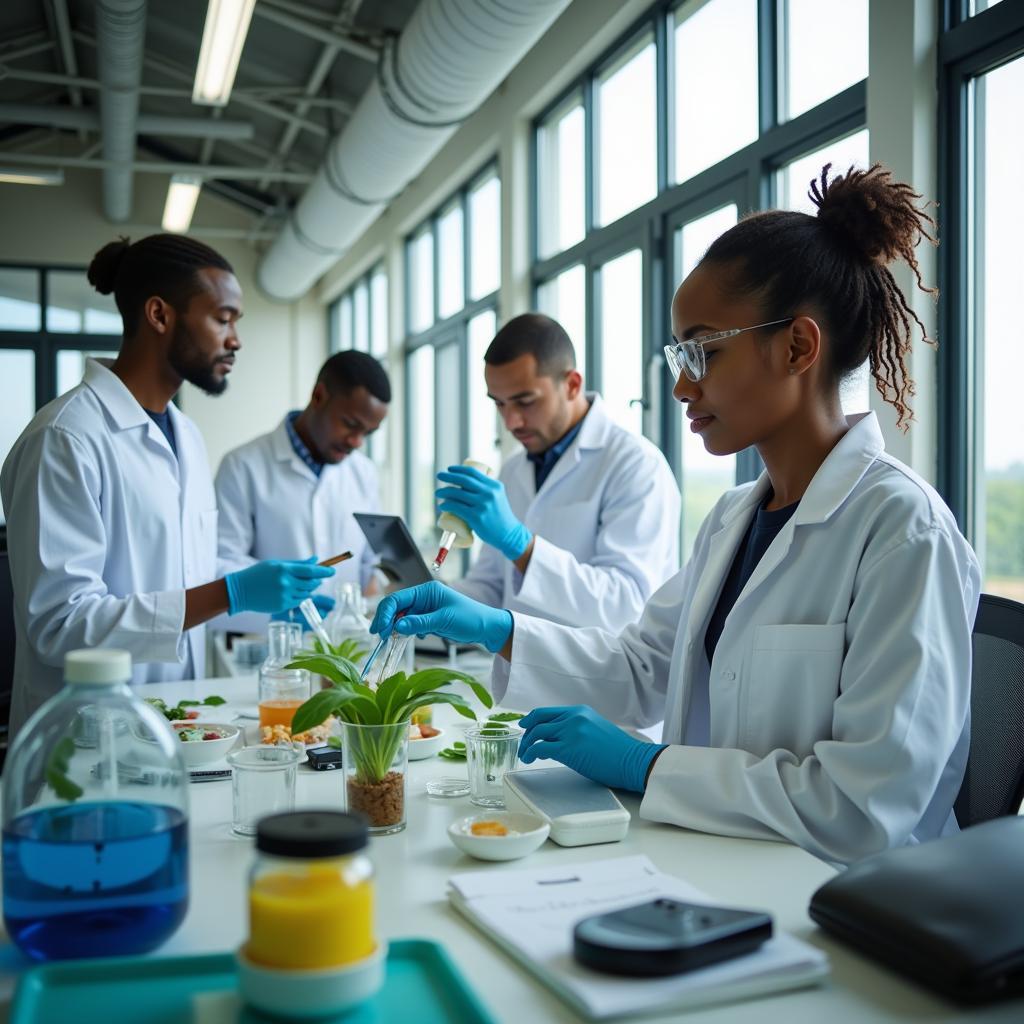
[373,165,980,862]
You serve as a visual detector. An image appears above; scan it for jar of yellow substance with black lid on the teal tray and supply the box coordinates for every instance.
[239,811,386,1016]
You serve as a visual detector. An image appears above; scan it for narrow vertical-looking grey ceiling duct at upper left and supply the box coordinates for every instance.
[96,0,145,222]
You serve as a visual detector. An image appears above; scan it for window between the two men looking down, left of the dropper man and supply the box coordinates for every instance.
[406,166,501,575]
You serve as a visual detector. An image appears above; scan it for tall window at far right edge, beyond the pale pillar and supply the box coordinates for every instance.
[939,2,1024,601]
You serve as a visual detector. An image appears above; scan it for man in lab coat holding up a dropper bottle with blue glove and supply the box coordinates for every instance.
[436,313,680,630]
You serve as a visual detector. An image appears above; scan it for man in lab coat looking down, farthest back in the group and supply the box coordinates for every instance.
[215,350,391,626]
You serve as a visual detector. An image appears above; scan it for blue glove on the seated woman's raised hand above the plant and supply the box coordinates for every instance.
[370,583,512,653]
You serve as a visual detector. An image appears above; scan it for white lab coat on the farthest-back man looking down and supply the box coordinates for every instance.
[215,420,380,630]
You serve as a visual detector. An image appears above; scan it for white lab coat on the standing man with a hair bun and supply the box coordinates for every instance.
[0,359,217,733]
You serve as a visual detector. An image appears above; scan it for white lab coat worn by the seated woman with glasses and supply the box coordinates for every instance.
[496,414,980,862]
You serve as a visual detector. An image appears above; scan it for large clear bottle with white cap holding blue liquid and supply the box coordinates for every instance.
[3,650,188,961]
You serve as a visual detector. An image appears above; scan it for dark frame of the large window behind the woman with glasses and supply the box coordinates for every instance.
[528,0,867,491]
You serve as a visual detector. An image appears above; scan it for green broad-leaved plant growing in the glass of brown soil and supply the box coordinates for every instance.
[288,653,494,783]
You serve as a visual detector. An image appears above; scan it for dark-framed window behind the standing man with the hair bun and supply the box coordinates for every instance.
[0,266,122,522]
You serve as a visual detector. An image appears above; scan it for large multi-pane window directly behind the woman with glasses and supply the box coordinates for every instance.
[532,0,868,553]
